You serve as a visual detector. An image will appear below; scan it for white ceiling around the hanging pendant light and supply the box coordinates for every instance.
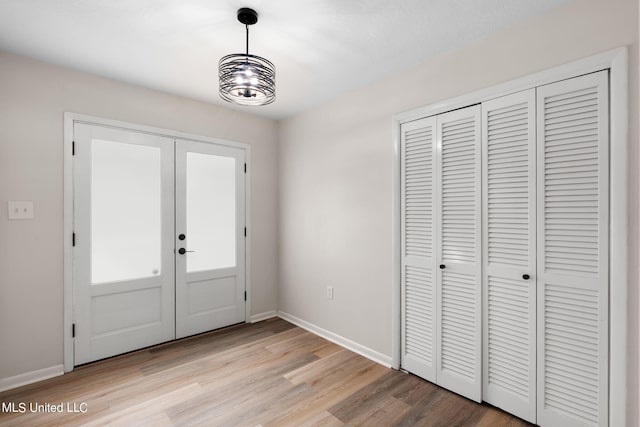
[0,0,567,119]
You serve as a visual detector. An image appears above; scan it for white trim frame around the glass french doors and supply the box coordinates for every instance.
[63,112,252,372]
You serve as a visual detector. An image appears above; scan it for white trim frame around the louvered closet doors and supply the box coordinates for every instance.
[391,47,629,426]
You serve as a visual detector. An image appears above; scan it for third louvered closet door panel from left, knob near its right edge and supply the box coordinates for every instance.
[482,89,536,423]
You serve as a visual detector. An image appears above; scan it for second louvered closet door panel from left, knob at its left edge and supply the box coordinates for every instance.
[436,105,482,402]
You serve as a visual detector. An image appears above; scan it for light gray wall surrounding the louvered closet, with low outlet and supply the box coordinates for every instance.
[279,0,639,425]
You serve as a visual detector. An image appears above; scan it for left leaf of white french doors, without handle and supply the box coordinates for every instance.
[74,123,175,365]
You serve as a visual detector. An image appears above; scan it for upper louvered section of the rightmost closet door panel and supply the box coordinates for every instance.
[544,87,599,275]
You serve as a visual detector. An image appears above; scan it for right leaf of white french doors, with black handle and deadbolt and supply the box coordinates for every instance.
[175,140,245,338]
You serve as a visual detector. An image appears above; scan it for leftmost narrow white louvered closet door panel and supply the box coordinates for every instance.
[401,118,436,382]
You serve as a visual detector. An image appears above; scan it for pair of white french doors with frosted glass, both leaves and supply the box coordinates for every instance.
[73,123,245,365]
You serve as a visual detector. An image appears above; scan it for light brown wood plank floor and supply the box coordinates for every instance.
[0,318,529,427]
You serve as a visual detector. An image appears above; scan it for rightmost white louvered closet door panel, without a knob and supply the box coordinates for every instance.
[537,71,609,427]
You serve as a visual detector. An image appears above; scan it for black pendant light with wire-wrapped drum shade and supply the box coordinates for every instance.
[218,7,276,105]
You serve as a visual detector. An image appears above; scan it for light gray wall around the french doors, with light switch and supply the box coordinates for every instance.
[0,52,278,379]
